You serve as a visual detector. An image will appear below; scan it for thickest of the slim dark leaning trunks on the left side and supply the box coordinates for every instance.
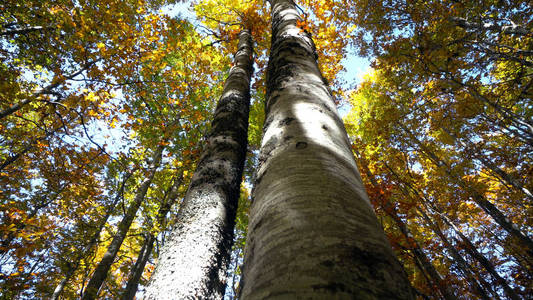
[82,146,165,300]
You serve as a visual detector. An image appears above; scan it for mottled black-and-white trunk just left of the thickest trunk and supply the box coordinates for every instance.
[145,30,253,299]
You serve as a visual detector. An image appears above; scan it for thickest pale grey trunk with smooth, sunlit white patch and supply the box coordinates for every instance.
[240,0,413,300]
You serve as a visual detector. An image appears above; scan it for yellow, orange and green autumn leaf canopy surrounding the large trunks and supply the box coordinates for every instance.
[0,0,533,299]
